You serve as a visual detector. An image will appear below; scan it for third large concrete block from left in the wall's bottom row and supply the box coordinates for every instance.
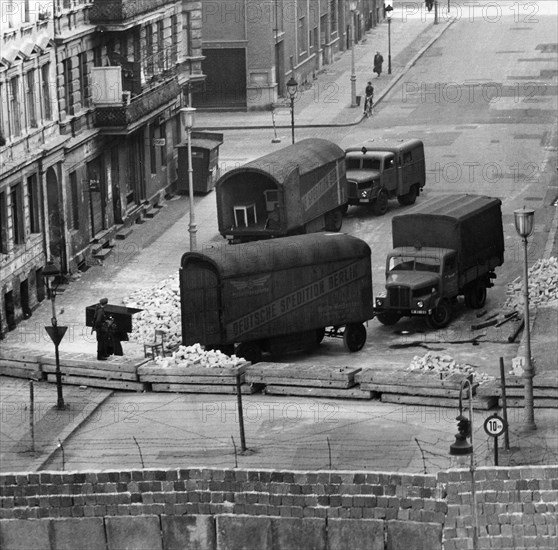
[105,516,163,550]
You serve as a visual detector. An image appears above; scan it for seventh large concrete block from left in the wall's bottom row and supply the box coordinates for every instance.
[327,518,388,550]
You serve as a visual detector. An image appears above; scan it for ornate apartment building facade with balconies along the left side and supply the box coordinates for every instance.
[0,0,204,335]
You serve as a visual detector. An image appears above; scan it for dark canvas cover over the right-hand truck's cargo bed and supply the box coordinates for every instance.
[392,194,504,265]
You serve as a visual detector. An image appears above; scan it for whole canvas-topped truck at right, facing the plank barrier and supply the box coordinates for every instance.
[374,194,504,328]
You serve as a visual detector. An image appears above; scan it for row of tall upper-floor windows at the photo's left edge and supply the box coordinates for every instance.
[0,63,52,138]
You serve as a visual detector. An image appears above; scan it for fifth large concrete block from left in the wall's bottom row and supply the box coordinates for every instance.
[216,514,272,550]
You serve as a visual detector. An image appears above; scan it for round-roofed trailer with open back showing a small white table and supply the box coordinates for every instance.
[216,139,347,243]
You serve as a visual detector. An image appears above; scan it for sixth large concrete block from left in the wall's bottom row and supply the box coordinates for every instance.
[270,518,326,550]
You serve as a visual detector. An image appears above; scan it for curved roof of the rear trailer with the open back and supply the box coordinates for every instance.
[217,138,345,190]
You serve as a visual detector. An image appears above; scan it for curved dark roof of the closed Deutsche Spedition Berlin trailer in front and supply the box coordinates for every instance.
[180,233,371,279]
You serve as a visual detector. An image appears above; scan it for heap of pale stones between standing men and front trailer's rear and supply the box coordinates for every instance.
[123,275,182,349]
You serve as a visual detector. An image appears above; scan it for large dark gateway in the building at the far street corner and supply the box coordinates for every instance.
[194,48,246,110]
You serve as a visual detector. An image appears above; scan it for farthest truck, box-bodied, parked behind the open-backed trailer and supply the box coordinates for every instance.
[345,139,426,216]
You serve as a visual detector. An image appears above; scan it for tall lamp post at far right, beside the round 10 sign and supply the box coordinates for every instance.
[513,207,537,431]
